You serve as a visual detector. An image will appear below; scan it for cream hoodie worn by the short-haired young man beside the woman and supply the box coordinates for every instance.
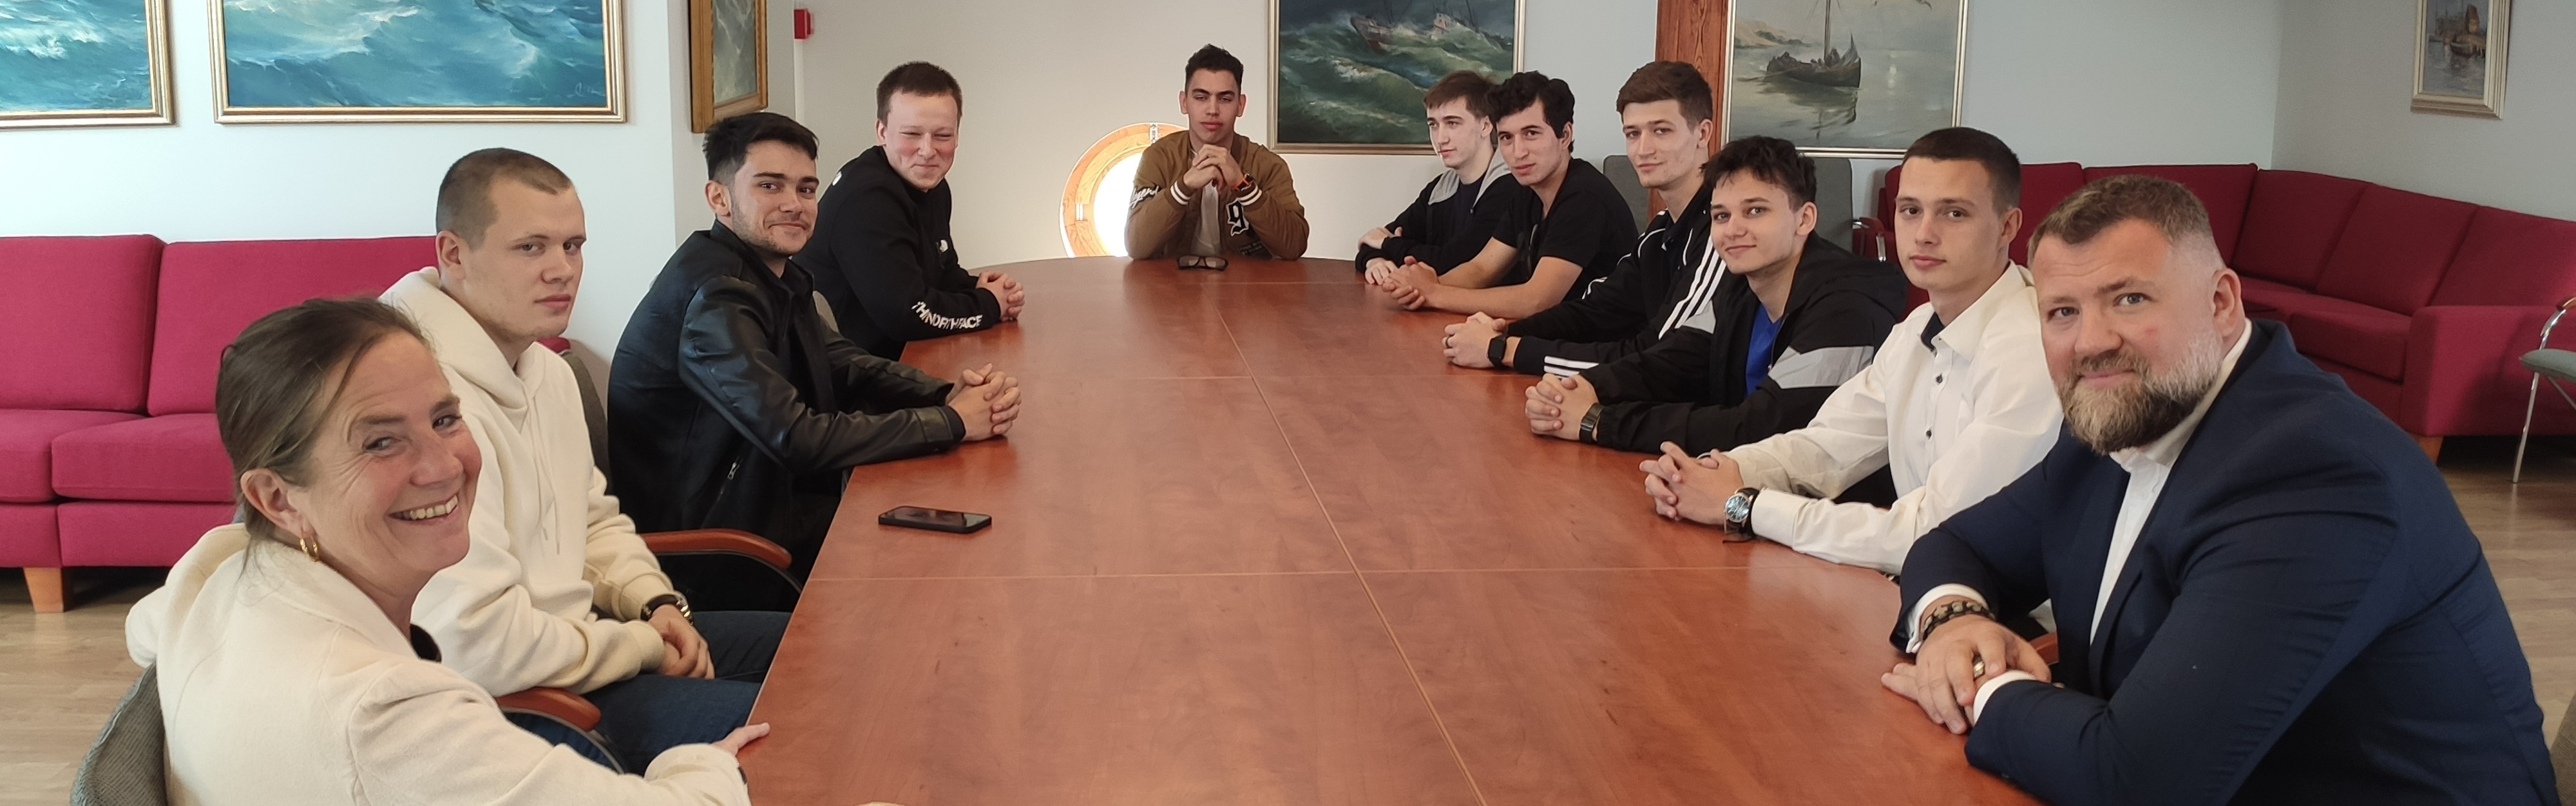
[384,268,673,695]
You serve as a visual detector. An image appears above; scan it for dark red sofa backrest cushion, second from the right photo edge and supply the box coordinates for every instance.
[2316,185,2478,314]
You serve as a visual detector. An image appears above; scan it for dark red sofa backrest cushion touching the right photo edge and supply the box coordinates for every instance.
[2432,206,2576,306]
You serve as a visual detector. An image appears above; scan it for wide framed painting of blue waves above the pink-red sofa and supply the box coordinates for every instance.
[211,0,626,124]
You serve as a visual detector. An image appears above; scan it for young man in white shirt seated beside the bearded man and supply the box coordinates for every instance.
[1641,129,2058,574]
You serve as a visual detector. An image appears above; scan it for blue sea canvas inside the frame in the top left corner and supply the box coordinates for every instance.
[0,0,152,113]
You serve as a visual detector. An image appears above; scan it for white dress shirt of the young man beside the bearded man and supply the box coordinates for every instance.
[1726,265,2061,574]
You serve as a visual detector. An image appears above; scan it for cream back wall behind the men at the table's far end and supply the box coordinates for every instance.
[801,0,1656,265]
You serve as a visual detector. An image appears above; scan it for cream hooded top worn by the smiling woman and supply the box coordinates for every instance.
[126,525,752,806]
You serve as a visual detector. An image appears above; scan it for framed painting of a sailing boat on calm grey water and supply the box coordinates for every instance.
[1721,0,1968,157]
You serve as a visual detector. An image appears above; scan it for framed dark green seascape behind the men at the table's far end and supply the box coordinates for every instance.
[1270,0,1522,155]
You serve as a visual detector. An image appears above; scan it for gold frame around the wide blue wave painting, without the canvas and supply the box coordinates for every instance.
[206,0,626,124]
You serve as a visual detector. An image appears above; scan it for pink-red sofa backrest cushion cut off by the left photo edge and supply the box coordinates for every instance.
[0,234,162,412]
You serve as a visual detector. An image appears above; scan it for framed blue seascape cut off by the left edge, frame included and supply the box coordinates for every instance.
[0,0,178,129]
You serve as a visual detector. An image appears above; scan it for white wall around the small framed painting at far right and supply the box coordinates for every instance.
[2275,0,2576,219]
